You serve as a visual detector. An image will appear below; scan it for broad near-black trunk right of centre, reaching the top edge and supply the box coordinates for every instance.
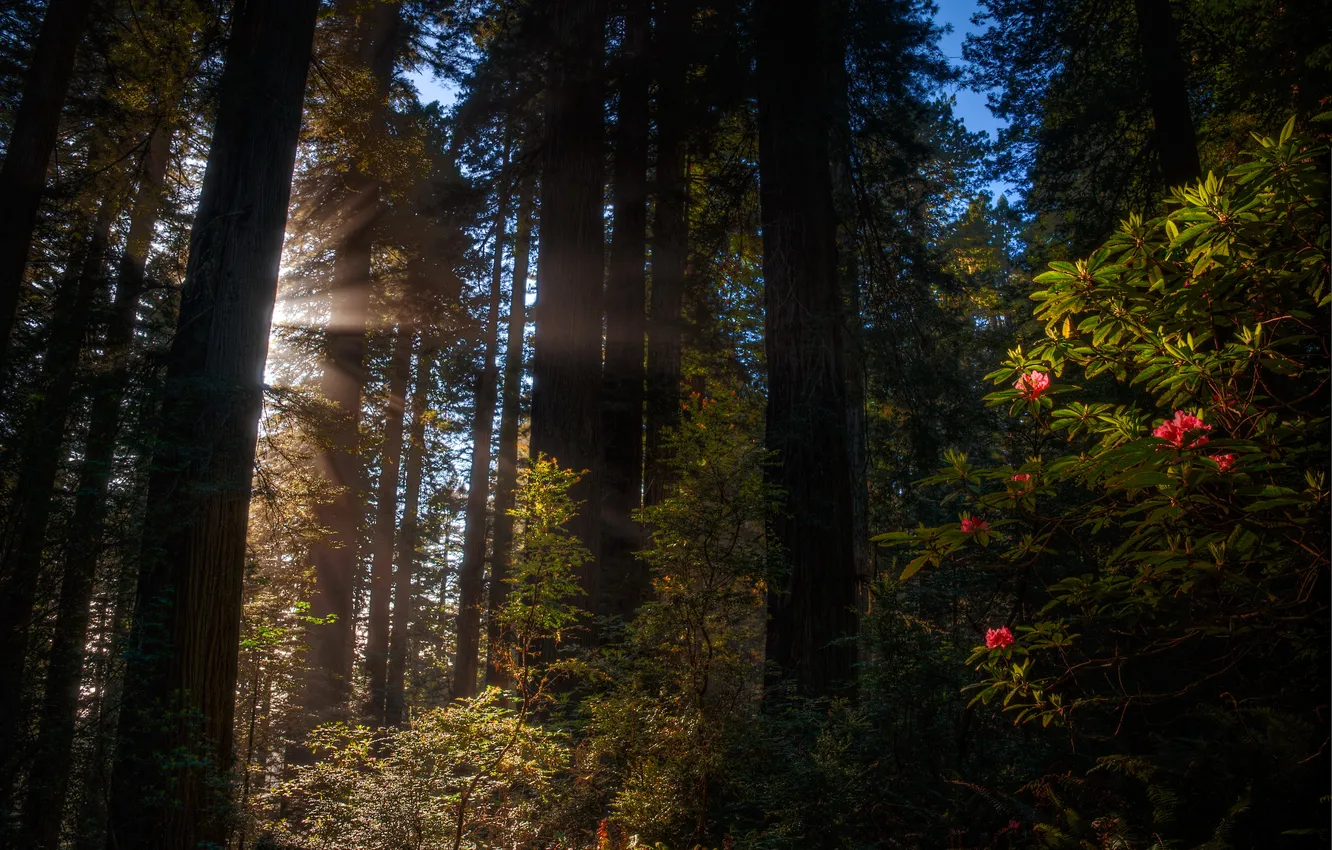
[755,0,856,695]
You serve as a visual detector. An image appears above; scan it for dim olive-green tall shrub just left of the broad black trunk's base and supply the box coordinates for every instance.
[583,393,773,846]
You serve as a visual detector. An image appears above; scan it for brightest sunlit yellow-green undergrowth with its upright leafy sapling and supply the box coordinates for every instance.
[270,457,589,850]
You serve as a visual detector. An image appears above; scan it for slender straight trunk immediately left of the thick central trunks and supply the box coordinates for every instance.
[486,179,533,686]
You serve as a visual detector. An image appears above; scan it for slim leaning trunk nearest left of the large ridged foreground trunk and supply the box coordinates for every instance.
[24,127,172,850]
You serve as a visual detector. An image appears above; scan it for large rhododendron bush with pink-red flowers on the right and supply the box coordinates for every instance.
[880,124,1328,847]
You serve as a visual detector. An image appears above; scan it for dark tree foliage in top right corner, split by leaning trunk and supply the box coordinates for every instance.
[963,0,1332,250]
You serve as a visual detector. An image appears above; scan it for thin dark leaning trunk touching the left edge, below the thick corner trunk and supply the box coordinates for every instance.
[0,195,119,820]
